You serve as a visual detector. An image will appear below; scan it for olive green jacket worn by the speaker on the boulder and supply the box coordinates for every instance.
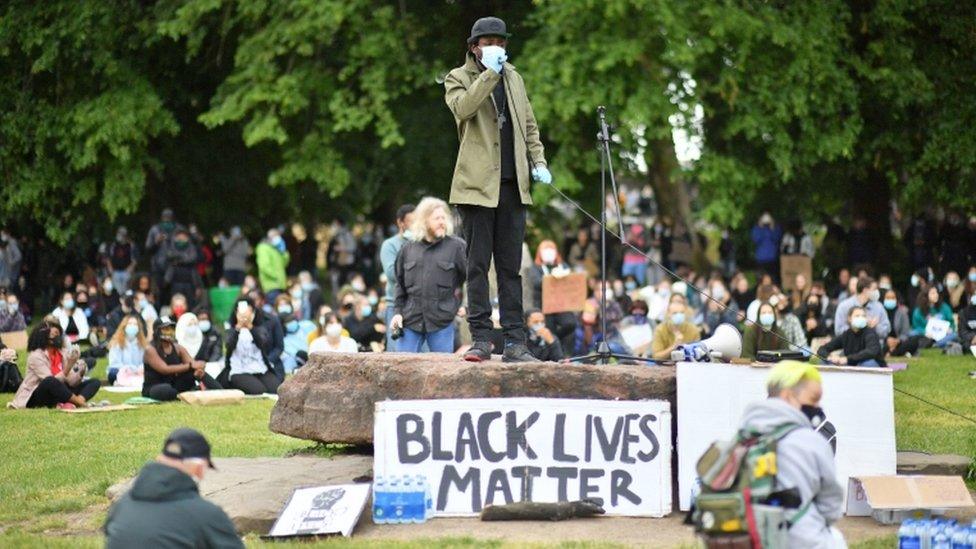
[444,53,546,208]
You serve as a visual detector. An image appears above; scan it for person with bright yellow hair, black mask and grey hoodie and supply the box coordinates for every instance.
[741,360,846,548]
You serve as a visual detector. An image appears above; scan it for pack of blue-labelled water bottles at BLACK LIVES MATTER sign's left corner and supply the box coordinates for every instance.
[373,475,433,524]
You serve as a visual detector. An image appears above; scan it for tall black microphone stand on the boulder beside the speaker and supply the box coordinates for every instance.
[569,105,657,364]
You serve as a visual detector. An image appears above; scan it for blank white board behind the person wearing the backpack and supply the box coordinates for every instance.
[677,362,897,511]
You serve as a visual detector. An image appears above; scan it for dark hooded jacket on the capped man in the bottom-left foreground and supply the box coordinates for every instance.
[104,462,244,549]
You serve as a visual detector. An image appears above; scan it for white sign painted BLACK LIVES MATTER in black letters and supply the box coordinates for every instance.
[373,398,671,517]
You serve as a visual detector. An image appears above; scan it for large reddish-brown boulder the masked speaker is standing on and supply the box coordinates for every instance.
[271,353,675,444]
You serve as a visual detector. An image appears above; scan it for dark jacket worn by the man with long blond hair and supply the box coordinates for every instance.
[394,236,468,332]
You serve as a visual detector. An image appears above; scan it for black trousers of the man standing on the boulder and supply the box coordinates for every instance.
[459,181,526,344]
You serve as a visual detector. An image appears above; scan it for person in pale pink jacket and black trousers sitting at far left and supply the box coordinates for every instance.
[10,322,102,409]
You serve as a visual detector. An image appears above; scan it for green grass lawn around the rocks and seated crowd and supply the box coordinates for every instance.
[0,352,976,548]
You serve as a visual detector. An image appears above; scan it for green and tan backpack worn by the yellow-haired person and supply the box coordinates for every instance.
[689,423,812,549]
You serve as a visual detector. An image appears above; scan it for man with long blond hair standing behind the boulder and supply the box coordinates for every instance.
[390,197,467,353]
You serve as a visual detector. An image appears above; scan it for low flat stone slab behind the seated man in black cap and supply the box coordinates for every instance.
[106,455,373,534]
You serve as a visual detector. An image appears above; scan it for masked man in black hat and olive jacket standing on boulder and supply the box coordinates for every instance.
[444,17,552,362]
